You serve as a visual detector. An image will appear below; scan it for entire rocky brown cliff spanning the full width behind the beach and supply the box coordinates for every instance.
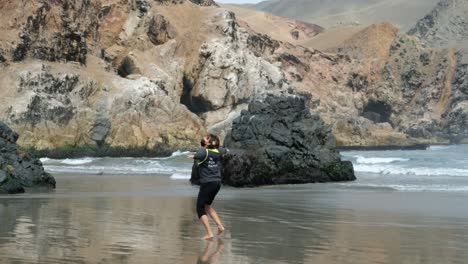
[0,0,468,148]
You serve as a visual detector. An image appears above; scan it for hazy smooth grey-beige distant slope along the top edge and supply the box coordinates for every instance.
[249,0,438,30]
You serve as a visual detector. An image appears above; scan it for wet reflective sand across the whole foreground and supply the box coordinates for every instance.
[0,174,468,263]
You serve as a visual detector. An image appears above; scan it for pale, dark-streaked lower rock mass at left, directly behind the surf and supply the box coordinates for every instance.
[0,64,205,149]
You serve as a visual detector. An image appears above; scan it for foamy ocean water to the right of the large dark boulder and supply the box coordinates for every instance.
[342,145,468,192]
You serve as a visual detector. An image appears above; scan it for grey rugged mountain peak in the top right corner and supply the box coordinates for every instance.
[408,0,468,47]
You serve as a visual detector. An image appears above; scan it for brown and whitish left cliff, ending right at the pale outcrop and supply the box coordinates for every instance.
[0,1,288,148]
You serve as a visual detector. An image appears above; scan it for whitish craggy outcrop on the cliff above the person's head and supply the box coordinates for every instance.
[181,9,292,136]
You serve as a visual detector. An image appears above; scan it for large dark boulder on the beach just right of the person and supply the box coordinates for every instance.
[222,95,356,187]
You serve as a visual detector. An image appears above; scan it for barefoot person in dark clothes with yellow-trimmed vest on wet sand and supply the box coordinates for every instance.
[187,134,226,239]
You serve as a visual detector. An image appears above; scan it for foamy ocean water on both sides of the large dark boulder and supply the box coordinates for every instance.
[41,145,468,192]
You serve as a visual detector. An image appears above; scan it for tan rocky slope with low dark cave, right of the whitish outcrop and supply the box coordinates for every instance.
[231,3,468,145]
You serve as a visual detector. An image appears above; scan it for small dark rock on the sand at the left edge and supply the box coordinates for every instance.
[0,122,55,193]
